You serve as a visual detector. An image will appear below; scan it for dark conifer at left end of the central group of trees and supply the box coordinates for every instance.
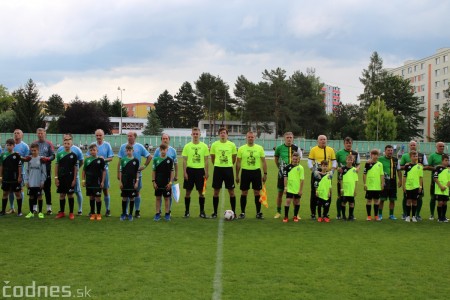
[155,90,180,128]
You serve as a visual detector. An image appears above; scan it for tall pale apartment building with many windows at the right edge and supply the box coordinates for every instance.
[388,48,450,141]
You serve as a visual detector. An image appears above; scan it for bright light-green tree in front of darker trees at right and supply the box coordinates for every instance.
[365,99,397,141]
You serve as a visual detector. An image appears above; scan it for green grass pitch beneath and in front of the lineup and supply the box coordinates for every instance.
[0,158,450,299]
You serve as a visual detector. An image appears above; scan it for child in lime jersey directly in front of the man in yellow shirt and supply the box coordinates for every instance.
[314,160,331,223]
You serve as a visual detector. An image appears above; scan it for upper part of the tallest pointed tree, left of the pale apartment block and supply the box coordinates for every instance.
[358,51,388,109]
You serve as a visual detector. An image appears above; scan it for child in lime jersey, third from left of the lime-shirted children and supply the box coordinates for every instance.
[339,153,358,221]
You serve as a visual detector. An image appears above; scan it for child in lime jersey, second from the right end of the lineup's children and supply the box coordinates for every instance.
[403,150,423,222]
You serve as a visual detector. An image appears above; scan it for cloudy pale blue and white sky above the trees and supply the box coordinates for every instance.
[0,0,450,103]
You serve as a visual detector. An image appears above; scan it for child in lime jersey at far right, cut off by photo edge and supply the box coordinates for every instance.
[433,154,450,223]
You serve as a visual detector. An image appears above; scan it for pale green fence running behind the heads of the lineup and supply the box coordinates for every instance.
[0,133,442,154]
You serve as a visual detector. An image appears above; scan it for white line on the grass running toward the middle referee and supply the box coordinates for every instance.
[212,187,225,300]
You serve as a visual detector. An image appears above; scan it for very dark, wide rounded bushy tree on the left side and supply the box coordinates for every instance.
[58,97,111,134]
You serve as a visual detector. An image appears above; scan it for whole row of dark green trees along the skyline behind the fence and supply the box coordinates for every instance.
[0,52,450,141]
